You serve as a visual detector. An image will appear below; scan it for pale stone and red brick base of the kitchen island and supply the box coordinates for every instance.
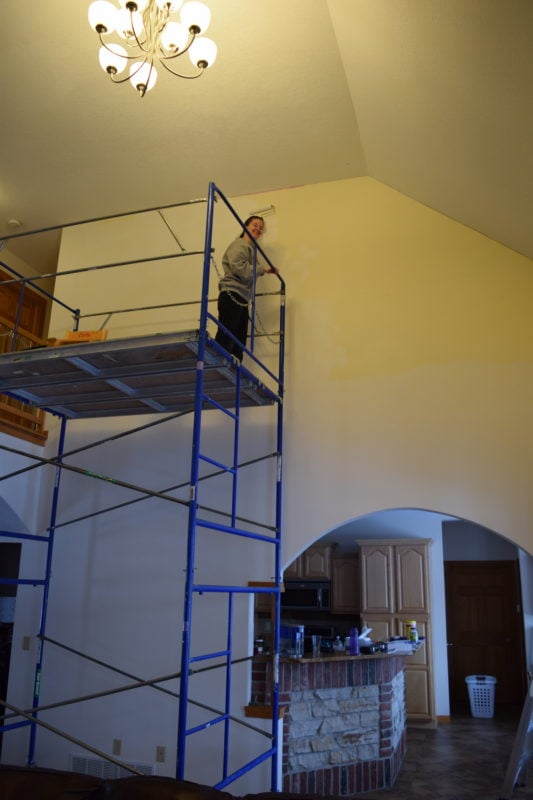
[252,653,406,796]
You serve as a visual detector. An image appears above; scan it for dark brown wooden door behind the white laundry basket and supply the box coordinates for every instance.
[444,561,527,711]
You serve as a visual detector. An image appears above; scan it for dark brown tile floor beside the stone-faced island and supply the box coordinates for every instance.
[356,714,533,800]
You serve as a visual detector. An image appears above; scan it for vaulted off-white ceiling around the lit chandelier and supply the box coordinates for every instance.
[0,0,533,270]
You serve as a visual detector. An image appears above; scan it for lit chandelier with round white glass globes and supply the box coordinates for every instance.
[89,0,217,97]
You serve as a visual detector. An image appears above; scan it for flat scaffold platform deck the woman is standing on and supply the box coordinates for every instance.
[0,331,275,419]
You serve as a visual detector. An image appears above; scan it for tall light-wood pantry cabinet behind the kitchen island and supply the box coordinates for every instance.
[358,539,436,725]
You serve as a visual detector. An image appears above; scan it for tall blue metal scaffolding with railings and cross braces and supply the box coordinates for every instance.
[0,183,285,791]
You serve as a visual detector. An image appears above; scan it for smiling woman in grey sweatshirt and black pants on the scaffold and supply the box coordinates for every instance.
[215,216,277,361]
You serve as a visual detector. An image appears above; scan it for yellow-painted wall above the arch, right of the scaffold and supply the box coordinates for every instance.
[239,178,533,561]
